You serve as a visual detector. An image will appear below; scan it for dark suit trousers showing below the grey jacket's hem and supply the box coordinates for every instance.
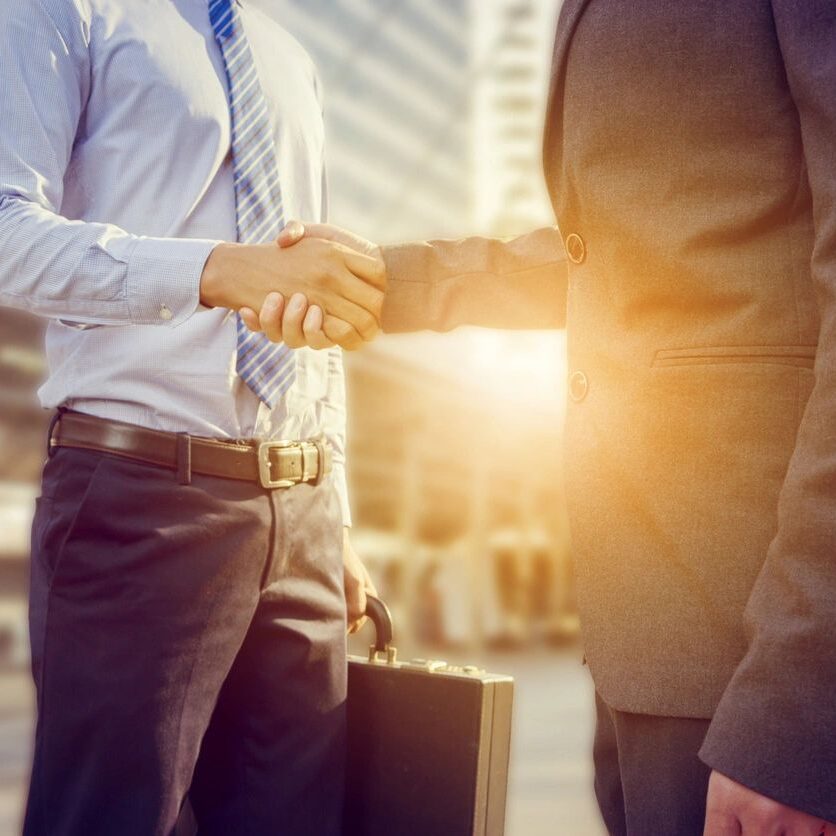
[593,693,711,836]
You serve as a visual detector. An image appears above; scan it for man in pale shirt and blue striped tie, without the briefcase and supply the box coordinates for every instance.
[0,0,383,836]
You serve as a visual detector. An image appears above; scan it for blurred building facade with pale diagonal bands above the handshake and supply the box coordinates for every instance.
[258,0,476,241]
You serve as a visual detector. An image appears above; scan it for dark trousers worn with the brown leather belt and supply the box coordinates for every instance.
[24,448,346,836]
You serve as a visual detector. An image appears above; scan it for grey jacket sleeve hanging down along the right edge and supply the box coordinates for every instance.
[701,0,836,822]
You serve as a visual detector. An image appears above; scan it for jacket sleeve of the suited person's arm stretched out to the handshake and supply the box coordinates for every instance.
[383,227,567,333]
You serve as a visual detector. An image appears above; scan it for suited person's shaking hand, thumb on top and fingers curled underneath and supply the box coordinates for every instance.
[240,221,386,349]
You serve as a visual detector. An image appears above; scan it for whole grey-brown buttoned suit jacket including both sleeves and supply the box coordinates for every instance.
[384,0,836,820]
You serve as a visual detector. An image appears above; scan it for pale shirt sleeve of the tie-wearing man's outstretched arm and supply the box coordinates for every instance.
[0,0,218,326]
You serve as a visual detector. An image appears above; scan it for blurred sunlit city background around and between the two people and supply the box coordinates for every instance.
[0,0,603,836]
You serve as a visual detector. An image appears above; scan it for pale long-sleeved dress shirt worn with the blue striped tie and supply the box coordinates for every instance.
[0,0,349,523]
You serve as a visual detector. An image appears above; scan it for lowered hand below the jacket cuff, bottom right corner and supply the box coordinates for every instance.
[703,772,836,836]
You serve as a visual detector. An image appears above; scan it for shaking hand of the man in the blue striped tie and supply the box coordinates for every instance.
[200,237,385,349]
